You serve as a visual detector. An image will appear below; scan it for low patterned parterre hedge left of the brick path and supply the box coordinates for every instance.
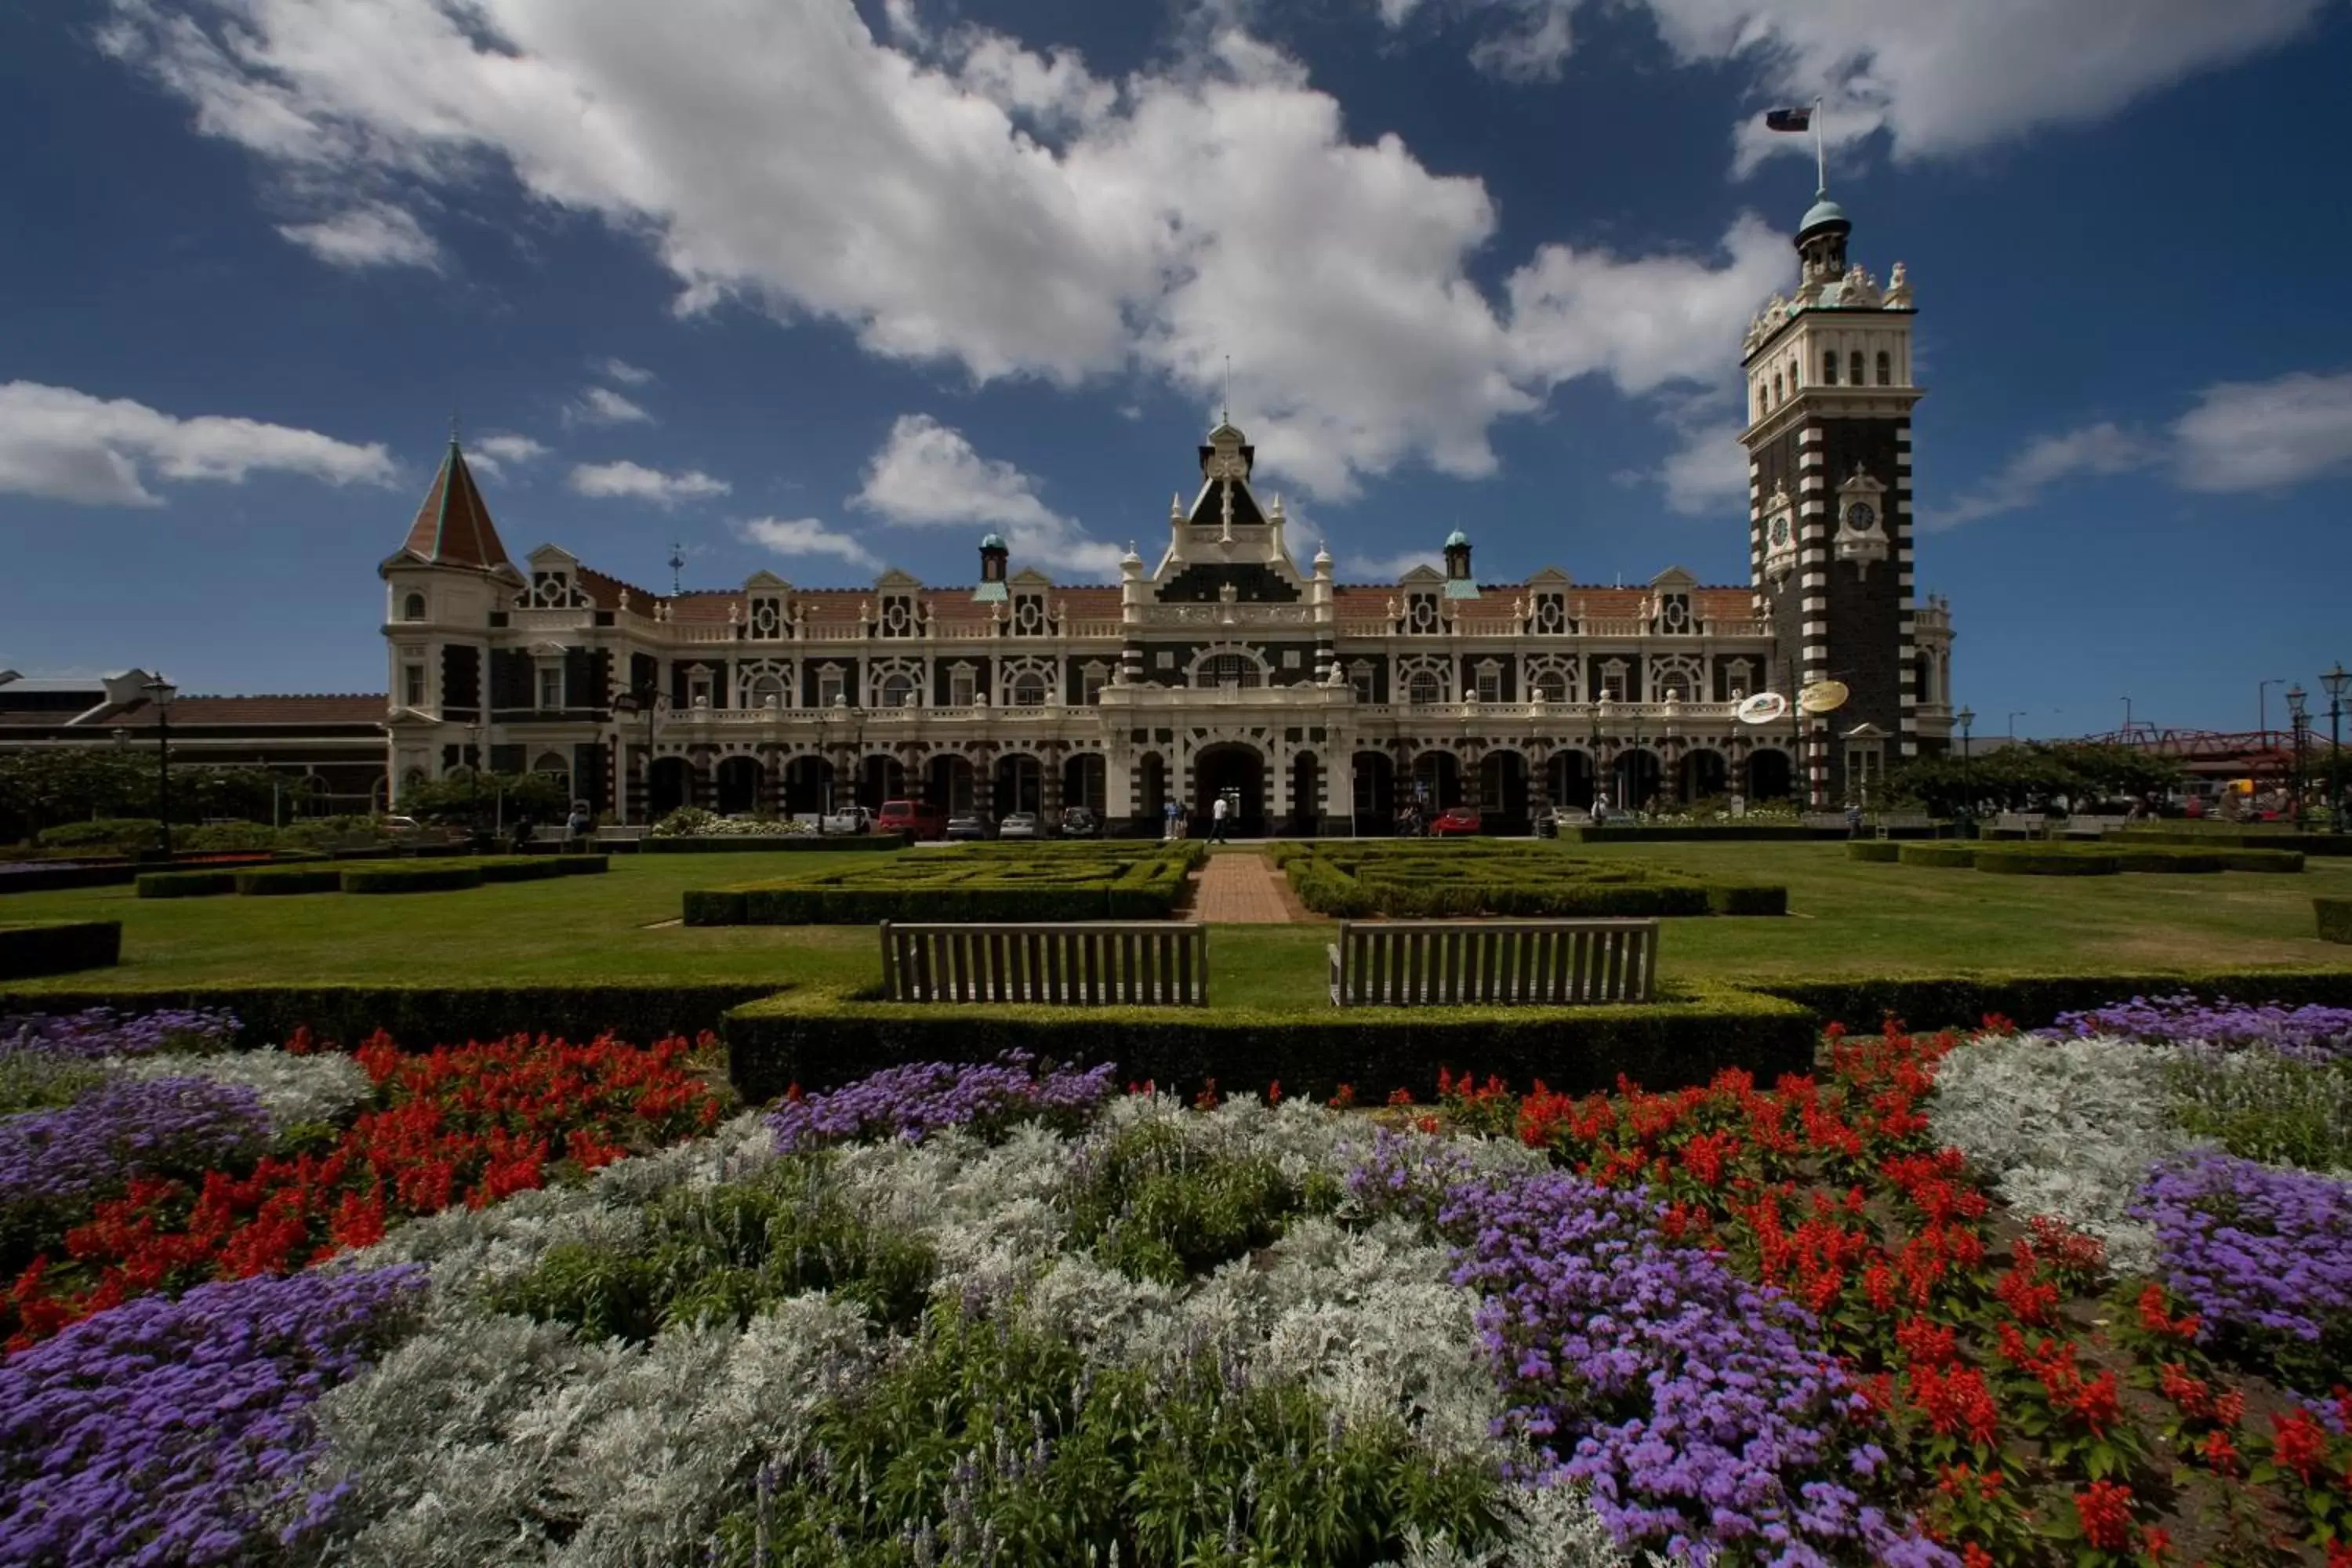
[684,844,1207,926]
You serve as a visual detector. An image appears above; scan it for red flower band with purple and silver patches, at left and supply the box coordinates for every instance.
[0,1015,720,1349]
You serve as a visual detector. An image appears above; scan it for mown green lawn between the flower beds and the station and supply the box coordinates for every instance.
[0,844,2352,1008]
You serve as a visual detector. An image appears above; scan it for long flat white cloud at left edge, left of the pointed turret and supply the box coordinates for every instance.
[0,381,397,506]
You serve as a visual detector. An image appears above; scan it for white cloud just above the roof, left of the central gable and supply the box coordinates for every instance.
[849,414,1120,576]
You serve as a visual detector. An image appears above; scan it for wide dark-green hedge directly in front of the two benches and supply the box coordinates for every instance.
[724,980,1816,1100]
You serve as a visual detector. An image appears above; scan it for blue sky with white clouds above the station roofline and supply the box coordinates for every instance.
[0,0,2352,734]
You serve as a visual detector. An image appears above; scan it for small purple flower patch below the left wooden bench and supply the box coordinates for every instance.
[767,1051,1115,1154]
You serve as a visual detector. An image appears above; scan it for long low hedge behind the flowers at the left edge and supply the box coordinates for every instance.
[0,980,776,1048]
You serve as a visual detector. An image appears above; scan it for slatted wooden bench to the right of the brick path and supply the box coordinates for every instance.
[1329,919,1658,1006]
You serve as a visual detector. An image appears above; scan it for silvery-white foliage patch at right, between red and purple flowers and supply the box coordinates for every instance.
[1929,1034,2206,1274]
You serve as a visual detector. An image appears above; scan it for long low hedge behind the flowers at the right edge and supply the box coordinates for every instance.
[1748,966,2352,1029]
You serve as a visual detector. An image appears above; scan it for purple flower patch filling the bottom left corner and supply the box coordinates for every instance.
[0,1265,423,1566]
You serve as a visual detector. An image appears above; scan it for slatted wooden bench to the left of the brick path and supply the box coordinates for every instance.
[882,919,1209,1006]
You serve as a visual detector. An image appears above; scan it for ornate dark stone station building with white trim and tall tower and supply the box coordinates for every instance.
[381,187,1952,832]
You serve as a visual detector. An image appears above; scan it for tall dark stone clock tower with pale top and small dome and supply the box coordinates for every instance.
[1740,193,1945,811]
